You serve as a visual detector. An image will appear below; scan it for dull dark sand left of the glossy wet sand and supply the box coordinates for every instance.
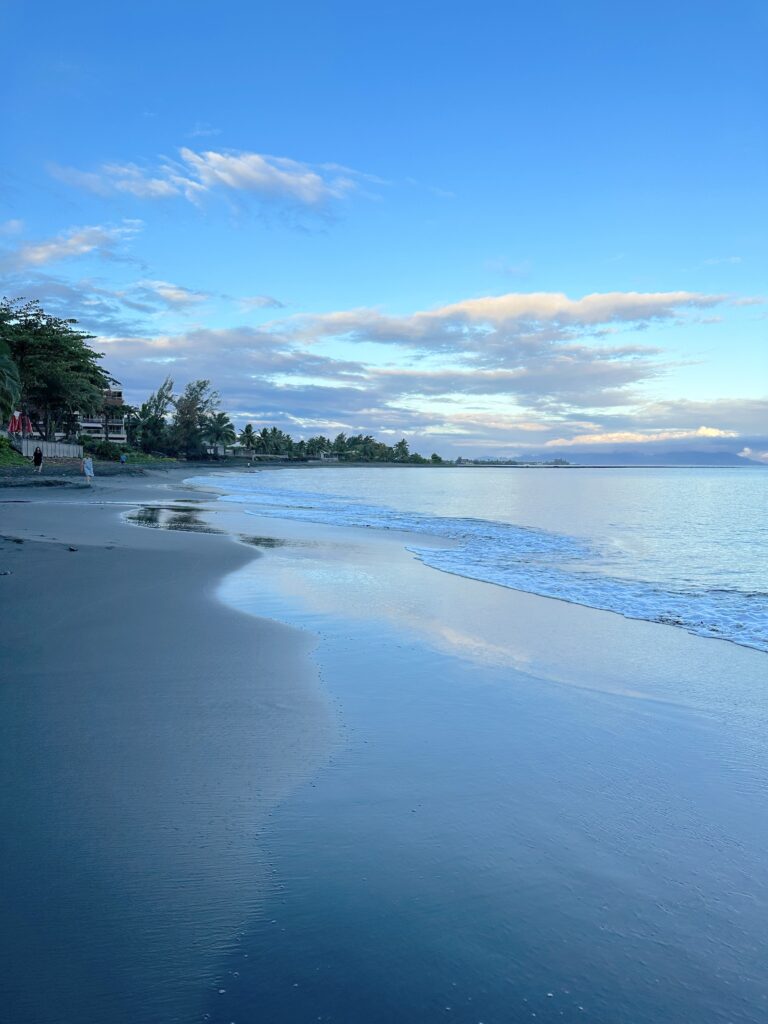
[0,471,335,1024]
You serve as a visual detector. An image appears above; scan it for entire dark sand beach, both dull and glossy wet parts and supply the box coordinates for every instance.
[0,471,768,1024]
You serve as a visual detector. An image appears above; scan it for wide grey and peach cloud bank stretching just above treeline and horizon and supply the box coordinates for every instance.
[1,270,757,454]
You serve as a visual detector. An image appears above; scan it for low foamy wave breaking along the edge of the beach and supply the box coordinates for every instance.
[188,477,768,652]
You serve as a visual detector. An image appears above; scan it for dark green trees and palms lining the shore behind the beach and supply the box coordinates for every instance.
[0,298,443,465]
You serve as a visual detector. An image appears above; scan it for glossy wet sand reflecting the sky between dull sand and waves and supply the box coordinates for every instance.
[214,520,768,1024]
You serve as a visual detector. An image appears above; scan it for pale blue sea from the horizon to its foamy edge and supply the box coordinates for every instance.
[195,467,768,651]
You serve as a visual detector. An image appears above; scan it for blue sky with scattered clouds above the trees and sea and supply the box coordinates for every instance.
[0,0,768,458]
